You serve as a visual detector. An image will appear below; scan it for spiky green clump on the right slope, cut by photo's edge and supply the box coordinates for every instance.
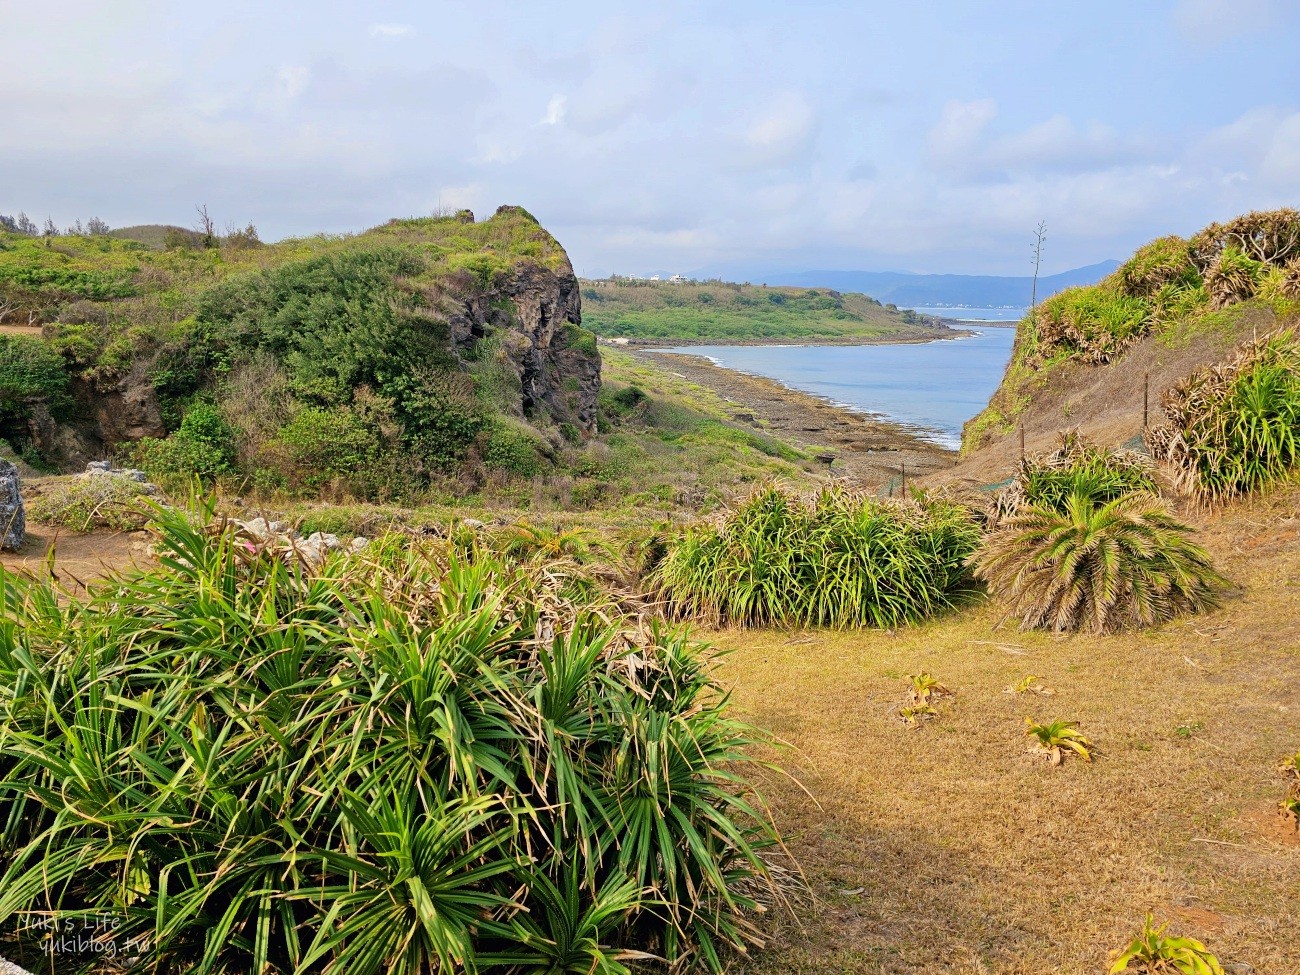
[1147,329,1300,504]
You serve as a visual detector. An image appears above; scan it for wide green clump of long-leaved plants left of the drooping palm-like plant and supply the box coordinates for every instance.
[654,486,979,627]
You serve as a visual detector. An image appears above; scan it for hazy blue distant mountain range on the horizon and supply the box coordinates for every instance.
[763,261,1119,308]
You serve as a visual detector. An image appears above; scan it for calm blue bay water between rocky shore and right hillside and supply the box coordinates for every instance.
[663,326,1015,449]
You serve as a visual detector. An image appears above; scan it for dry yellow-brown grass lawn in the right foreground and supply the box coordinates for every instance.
[712,486,1300,975]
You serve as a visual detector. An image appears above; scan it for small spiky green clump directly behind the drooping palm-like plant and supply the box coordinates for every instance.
[989,430,1160,528]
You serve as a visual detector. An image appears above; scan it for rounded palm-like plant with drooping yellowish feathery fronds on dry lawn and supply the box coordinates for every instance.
[972,494,1225,633]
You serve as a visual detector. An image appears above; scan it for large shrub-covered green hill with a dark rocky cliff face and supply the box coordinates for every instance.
[0,207,599,494]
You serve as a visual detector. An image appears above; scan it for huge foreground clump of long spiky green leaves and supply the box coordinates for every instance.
[0,499,776,975]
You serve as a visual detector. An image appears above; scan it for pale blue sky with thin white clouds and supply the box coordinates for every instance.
[0,0,1300,281]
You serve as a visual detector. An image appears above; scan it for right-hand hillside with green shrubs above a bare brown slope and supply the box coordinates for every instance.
[963,209,1300,452]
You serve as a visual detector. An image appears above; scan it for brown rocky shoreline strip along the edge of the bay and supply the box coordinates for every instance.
[636,350,957,493]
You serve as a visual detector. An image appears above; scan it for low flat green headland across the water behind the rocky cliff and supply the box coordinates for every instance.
[582,278,937,342]
